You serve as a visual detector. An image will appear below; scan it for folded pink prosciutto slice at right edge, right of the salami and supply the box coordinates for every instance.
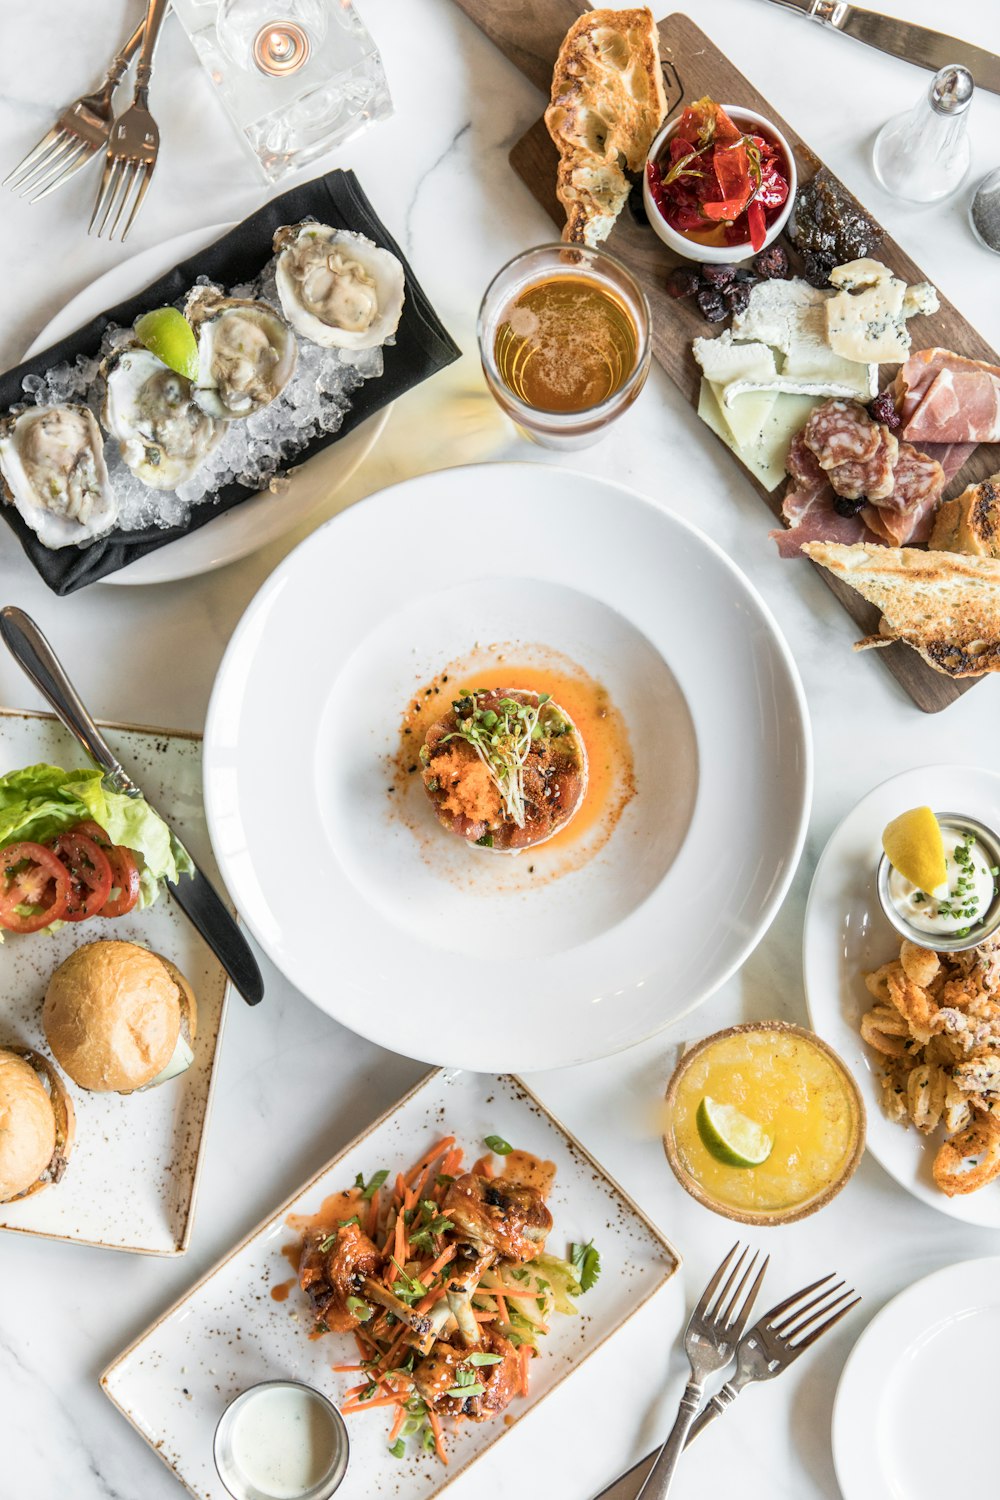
[892,350,1000,443]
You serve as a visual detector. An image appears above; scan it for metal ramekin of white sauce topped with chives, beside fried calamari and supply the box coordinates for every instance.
[876,813,1000,953]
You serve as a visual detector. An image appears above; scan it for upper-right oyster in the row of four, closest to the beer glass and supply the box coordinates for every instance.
[274,221,405,350]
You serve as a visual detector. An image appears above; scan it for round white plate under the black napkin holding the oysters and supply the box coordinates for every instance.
[24,224,393,584]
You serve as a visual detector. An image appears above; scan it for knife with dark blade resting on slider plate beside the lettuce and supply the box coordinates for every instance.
[0,605,264,1005]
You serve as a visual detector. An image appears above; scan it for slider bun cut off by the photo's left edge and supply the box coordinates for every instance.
[0,1047,75,1203]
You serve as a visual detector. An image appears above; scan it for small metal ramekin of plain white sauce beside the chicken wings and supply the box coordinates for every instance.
[214,1380,349,1500]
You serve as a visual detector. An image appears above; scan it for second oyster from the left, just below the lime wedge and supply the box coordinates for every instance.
[100,344,226,489]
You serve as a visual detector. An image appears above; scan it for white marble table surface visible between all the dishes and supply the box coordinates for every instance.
[0,0,1000,1500]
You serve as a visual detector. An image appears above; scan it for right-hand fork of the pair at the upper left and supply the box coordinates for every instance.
[87,0,169,240]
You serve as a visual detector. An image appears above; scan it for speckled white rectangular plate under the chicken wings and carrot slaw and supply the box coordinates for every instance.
[100,1070,681,1500]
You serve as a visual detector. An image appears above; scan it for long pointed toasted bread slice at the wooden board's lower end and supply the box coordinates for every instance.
[802,542,1000,677]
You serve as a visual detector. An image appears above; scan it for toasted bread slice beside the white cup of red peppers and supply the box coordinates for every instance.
[546,9,667,245]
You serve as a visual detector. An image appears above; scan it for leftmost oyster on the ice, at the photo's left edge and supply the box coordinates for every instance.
[0,404,118,551]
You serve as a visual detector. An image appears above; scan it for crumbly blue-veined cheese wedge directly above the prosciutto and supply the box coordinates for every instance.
[826,260,937,365]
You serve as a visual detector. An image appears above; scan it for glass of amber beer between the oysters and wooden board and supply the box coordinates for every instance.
[477,245,651,449]
